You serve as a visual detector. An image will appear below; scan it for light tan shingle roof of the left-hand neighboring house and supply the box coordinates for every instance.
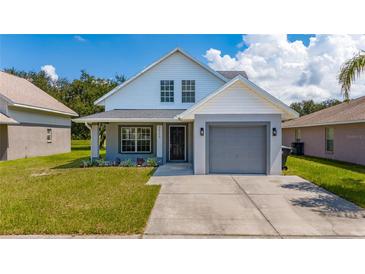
[0,71,77,116]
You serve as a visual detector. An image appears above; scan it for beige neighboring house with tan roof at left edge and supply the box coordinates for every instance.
[0,71,78,161]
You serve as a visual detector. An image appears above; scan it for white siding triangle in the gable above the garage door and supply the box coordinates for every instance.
[194,82,281,114]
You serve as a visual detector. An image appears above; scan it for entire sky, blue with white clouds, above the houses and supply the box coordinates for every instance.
[0,34,365,103]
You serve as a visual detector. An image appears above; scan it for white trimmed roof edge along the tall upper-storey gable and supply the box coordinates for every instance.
[94,48,228,105]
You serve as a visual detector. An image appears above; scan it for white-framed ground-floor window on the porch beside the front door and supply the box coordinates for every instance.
[121,127,152,153]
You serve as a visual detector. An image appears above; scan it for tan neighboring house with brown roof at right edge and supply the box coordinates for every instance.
[282,96,365,165]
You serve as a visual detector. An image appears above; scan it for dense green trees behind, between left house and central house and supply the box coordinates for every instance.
[4,68,126,146]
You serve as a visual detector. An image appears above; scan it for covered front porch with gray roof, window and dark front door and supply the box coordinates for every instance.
[74,109,194,165]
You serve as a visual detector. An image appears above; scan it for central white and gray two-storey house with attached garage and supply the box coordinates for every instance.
[74,49,298,174]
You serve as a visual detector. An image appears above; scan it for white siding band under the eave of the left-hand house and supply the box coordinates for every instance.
[9,107,71,126]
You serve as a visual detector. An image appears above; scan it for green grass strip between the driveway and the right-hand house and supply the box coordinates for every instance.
[285,156,365,207]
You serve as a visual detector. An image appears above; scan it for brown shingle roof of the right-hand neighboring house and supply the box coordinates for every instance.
[283,96,365,128]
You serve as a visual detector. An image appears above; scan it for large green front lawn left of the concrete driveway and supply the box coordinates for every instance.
[0,141,160,234]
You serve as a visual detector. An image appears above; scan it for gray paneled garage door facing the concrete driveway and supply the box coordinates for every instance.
[209,126,267,174]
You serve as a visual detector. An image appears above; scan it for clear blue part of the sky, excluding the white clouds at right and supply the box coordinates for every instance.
[0,34,310,79]
